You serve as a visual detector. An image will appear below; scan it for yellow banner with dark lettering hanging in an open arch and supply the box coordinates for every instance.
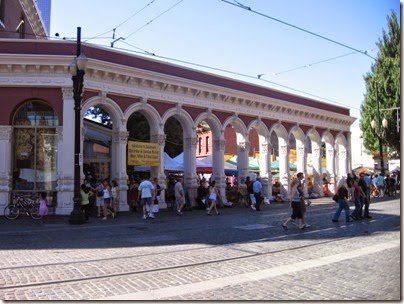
[128,141,160,166]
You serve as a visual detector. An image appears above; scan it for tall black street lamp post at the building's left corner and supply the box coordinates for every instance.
[69,27,87,225]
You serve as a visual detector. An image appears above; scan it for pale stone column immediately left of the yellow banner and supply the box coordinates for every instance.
[111,131,129,211]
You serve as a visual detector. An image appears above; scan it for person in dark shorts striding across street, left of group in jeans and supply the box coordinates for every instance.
[282,172,310,230]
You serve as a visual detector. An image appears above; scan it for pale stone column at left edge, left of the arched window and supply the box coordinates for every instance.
[0,126,13,210]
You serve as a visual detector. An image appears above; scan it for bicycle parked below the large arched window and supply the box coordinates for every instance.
[4,195,41,220]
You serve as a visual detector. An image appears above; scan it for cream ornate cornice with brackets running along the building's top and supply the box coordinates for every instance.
[0,48,355,131]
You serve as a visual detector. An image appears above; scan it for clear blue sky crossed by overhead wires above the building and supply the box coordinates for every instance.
[50,0,400,166]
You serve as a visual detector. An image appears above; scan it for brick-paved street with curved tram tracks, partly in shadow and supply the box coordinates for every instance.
[0,199,401,301]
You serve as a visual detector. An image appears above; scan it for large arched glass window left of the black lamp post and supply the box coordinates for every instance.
[13,100,59,192]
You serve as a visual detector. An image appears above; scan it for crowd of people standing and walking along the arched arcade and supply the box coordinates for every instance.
[71,172,400,230]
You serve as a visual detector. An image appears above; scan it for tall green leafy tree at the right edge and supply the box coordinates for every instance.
[360,11,401,158]
